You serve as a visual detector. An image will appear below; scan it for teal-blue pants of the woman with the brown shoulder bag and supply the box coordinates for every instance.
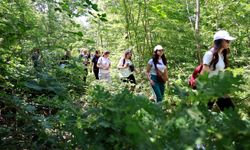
[151,74,165,102]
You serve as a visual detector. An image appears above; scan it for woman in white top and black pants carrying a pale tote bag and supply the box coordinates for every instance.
[117,50,136,84]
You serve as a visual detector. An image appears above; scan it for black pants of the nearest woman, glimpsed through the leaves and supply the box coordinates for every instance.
[207,97,235,111]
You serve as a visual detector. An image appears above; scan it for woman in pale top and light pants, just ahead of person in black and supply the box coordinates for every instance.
[97,51,111,82]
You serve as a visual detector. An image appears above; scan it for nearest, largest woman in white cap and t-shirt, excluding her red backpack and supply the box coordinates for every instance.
[201,30,235,111]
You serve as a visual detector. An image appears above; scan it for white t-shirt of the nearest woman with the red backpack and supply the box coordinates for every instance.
[203,49,225,77]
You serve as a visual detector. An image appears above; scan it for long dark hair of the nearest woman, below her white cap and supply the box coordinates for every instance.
[209,39,230,70]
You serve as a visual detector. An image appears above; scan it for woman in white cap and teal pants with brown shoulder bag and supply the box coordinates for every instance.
[146,45,168,102]
